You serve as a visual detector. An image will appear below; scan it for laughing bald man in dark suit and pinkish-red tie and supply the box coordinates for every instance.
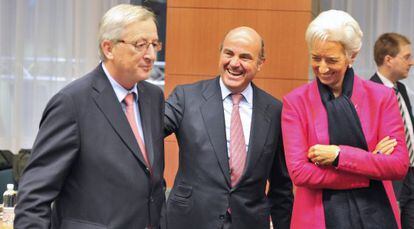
[165,27,293,229]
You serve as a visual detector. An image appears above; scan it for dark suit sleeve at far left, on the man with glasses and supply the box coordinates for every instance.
[14,93,80,229]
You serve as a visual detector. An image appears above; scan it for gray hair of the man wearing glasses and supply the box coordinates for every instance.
[98,4,156,60]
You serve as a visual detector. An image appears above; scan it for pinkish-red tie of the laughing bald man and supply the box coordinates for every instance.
[230,94,246,187]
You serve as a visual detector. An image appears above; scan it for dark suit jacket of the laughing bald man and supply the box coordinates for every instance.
[165,77,293,229]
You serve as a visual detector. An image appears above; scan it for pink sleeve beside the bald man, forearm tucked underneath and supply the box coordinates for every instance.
[282,97,369,190]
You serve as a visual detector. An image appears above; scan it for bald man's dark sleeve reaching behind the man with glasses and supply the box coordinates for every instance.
[164,86,184,137]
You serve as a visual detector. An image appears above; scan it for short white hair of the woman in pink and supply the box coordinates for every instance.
[305,10,363,58]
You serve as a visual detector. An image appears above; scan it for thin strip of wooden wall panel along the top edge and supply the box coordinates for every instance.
[168,0,312,12]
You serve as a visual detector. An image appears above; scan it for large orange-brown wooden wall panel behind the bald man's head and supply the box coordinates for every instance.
[166,8,311,79]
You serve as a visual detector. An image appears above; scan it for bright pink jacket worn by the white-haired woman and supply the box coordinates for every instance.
[282,75,408,229]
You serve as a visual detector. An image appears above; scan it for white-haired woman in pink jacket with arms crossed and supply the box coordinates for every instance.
[282,10,408,229]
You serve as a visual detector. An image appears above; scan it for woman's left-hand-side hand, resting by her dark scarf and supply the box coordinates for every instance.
[308,144,340,166]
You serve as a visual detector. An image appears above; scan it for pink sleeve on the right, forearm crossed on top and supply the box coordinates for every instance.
[337,90,408,180]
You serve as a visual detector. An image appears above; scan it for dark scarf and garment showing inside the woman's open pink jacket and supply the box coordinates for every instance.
[317,68,397,229]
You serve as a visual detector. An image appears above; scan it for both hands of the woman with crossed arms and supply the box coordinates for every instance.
[308,136,397,166]
